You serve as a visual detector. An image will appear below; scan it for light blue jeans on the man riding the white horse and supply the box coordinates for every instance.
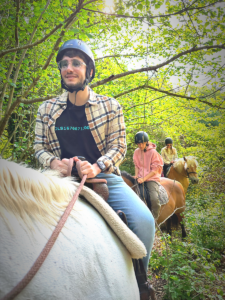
[97,173,155,272]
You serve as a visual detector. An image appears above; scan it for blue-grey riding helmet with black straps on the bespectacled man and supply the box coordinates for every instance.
[56,39,95,93]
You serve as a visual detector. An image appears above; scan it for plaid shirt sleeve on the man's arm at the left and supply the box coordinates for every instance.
[34,104,60,167]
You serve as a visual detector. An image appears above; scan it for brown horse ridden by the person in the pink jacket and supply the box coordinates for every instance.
[121,171,186,238]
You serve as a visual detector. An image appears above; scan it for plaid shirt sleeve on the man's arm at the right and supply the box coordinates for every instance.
[98,104,127,174]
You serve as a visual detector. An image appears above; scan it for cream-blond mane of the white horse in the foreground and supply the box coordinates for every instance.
[0,159,76,225]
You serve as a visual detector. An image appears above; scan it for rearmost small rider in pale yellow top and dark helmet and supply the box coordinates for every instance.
[161,137,178,177]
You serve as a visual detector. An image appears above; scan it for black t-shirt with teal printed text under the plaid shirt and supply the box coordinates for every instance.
[55,100,102,164]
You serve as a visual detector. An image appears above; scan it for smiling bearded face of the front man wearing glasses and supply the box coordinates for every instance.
[61,56,86,88]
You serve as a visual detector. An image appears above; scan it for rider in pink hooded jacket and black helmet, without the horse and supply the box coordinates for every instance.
[133,131,163,219]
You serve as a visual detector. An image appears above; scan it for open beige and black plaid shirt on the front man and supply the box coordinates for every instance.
[34,88,126,175]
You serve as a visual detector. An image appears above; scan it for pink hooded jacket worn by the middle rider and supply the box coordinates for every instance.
[133,143,163,182]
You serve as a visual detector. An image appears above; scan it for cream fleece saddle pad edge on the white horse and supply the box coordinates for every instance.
[74,182,147,259]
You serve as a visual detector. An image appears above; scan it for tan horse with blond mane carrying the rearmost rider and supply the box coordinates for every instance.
[167,156,199,194]
